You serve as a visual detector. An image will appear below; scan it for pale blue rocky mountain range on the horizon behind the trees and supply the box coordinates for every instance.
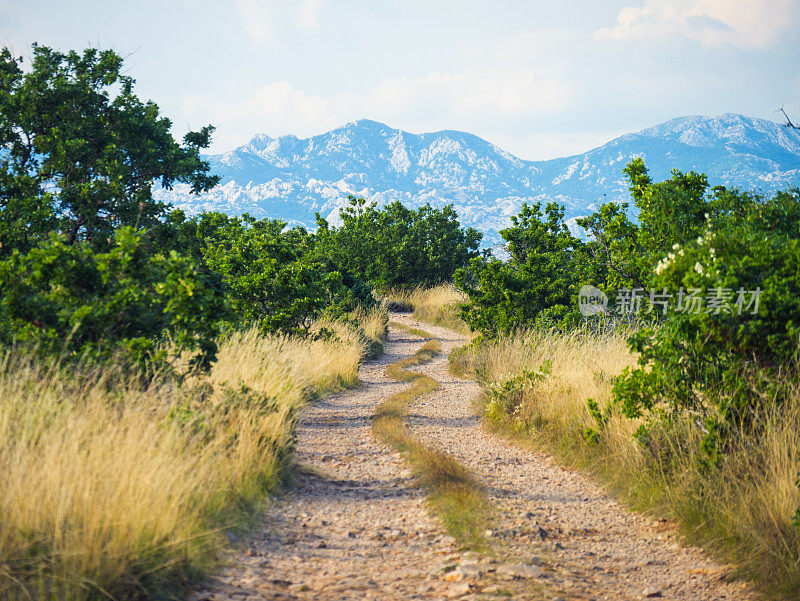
[156,114,800,244]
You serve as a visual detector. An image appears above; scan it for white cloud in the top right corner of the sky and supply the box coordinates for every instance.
[595,0,800,48]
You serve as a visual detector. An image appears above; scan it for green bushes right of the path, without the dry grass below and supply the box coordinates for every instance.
[456,159,800,460]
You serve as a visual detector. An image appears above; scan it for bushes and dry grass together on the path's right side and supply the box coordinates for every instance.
[451,159,800,598]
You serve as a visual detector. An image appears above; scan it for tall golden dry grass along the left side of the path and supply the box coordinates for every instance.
[0,318,379,601]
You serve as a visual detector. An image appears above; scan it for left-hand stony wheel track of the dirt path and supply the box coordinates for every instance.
[194,332,462,601]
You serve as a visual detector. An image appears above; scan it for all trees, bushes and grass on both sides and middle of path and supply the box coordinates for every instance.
[6,39,800,601]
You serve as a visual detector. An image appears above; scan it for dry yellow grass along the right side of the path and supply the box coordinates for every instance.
[451,332,800,599]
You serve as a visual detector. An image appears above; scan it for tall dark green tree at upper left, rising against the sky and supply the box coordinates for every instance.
[0,45,218,256]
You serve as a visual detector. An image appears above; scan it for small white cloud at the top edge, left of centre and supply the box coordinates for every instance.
[236,0,322,42]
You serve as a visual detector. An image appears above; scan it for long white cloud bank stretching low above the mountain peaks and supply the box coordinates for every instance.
[179,70,576,151]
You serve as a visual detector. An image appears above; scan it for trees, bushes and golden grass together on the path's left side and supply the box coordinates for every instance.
[0,46,468,601]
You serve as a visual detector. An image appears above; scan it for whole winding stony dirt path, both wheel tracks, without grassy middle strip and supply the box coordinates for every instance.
[190,315,753,601]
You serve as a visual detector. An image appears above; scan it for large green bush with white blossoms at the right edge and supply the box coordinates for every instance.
[614,190,800,454]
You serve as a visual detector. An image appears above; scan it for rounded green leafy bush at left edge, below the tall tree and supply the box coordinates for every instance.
[0,228,222,369]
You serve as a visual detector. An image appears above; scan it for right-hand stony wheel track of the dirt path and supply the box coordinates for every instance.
[394,316,758,601]
